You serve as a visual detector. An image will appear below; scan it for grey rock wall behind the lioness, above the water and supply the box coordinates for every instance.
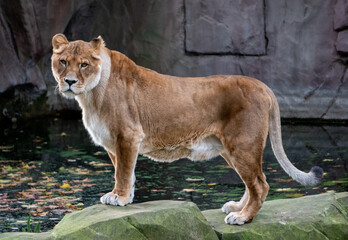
[0,0,348,119]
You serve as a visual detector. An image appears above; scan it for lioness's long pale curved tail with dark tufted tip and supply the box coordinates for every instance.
[269,89,323,186]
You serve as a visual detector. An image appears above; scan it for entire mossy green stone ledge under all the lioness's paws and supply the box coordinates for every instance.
[0,192,348,240]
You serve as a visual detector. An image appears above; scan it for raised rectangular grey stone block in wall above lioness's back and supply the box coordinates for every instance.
[185,0,266,55]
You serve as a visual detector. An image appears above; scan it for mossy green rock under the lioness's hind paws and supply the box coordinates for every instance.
[203,192,348,240]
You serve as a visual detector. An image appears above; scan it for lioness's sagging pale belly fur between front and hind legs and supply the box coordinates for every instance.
[139,136,223,162]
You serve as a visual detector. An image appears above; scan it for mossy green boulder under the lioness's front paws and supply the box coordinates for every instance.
[0,201,218,240]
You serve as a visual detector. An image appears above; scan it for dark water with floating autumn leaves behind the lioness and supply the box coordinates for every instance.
[0,118,348,232]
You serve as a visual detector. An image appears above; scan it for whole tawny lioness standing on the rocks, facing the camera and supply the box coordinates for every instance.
[52,34,323,225]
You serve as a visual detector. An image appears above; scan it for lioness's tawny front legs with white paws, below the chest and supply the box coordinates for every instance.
[100,138,138,206]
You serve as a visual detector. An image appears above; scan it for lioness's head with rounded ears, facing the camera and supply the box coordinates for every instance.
[51,34,104,98]
